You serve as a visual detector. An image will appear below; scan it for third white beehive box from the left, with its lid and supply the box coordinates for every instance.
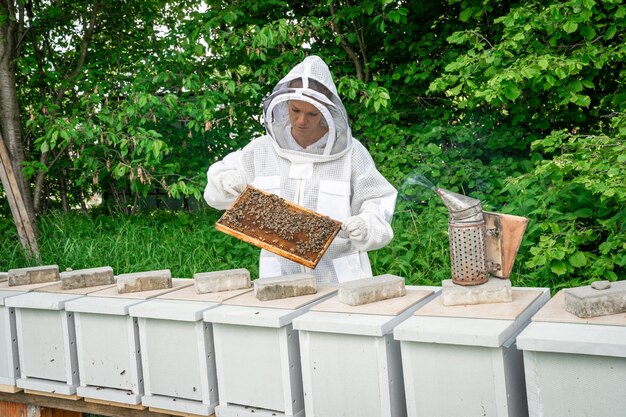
[66,279,193,407]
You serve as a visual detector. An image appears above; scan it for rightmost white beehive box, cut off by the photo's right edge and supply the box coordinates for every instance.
[517,291,626,417]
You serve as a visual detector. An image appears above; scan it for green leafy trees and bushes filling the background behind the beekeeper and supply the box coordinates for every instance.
[0,0,626,289]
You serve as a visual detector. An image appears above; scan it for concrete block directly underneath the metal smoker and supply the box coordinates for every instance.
[441,278,513,306]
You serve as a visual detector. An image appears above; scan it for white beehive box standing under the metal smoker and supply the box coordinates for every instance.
[394,288,550,417]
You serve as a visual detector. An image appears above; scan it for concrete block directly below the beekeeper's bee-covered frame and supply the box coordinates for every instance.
[254,273,317,301]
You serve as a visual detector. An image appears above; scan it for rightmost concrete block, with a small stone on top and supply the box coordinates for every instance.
[564,281,626,318]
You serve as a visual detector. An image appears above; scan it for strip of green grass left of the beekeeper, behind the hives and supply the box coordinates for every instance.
[0,210,258,278]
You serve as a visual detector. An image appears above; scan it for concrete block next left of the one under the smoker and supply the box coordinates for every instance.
[337,274,406,306]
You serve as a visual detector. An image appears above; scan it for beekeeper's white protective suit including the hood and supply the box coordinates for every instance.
[204,56,397,283]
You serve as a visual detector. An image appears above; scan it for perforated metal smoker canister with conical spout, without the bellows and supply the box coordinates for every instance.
[435,188,489,285]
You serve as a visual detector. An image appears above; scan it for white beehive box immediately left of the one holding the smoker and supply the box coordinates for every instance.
[293,286,439,417]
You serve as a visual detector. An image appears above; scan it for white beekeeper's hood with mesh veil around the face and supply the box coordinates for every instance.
[263,55,352,161]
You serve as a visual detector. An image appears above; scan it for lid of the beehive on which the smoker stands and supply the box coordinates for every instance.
[394,288,550,347]
